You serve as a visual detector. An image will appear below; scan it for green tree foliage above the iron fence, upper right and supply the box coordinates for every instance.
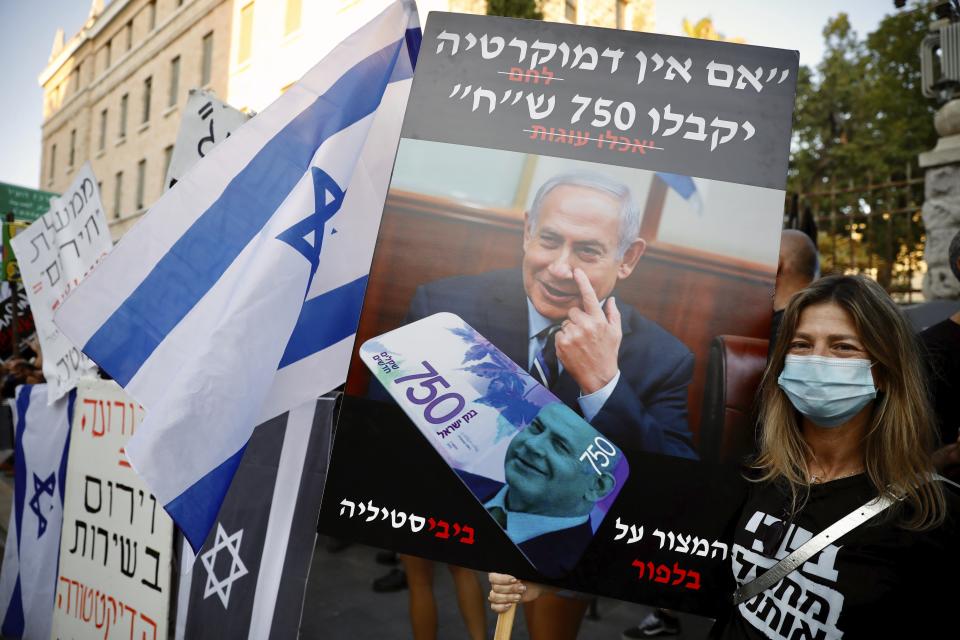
[790,4,936,191]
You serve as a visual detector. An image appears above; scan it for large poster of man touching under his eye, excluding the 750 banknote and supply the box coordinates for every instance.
[321,13,798,614]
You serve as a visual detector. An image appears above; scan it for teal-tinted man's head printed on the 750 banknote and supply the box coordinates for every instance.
[504,403,620,517]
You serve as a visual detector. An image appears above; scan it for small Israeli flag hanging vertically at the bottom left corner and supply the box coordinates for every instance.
[0,384,74,640]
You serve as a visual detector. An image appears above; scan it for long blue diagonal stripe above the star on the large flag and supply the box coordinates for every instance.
[83,40,403,386]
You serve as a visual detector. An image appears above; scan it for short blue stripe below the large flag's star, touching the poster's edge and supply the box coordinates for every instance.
[278,276,367,369]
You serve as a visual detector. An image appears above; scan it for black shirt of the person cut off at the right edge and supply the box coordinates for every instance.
[920,318,960,444]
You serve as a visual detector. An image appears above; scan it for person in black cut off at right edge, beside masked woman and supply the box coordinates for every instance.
[920,232,960,479]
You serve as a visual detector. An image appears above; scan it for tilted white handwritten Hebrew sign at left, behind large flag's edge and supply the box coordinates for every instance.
[10,163,113,401]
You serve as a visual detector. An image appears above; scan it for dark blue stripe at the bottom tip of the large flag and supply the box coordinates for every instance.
[163,445,247,553]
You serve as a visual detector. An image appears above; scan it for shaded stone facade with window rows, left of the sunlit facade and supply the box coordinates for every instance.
[39,0,231,237]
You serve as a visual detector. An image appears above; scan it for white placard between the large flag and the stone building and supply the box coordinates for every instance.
[164,89,250,189]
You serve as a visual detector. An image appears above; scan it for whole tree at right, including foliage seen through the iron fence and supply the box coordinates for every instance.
[788,2,937,290]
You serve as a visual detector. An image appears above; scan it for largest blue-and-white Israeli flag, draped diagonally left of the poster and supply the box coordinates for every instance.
[56,0,421,551]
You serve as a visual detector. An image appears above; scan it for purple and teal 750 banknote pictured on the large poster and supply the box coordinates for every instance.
[360,313,629,577]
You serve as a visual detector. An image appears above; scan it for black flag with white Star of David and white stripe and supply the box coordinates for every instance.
[176,397,335,640]
